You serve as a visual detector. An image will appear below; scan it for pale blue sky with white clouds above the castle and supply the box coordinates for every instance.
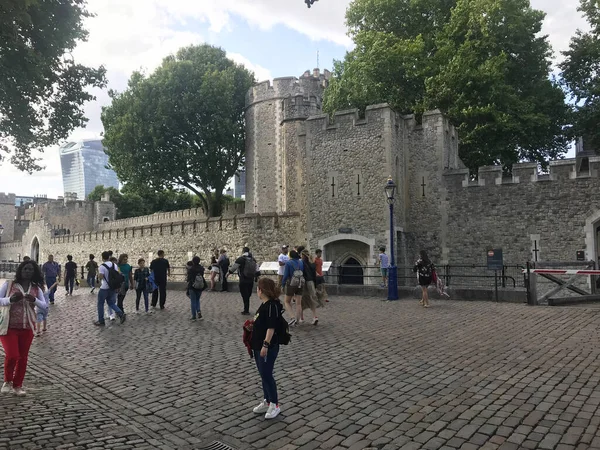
[0,0,586,198]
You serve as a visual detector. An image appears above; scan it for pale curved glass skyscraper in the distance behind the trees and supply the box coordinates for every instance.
[60,140,119,200]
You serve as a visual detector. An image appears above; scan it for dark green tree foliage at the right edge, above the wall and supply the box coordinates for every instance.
[560,0,600,152]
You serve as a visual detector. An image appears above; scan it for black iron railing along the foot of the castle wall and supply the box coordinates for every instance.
[325,264,526,289]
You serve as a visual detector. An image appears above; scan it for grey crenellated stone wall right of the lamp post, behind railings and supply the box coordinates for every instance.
[441,157,600,264]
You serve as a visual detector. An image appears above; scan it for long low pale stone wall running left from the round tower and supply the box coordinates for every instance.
[0,214,302,266]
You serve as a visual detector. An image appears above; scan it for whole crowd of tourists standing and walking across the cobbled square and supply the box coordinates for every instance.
[0,245,435,419]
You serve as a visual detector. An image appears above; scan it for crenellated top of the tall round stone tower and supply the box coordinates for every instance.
[246,69,331,108]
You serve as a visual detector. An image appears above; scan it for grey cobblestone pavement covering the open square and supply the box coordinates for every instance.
[0,289,600,450]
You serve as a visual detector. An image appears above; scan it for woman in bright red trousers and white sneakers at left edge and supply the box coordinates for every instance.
[0,260,48,396]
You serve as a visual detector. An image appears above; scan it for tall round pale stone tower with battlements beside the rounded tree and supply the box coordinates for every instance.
[246,69,330,213]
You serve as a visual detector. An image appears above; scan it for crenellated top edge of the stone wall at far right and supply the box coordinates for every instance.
[444,156,600,187]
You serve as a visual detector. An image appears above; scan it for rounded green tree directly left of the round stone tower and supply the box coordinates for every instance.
[102,45,254,216]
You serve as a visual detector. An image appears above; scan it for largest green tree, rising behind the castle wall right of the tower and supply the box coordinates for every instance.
[324,0,569,171]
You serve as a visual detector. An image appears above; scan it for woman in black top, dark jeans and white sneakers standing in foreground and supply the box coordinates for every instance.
[252,278,283,419]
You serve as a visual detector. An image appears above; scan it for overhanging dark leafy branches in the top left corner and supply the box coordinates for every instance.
[0,0,105,173]
